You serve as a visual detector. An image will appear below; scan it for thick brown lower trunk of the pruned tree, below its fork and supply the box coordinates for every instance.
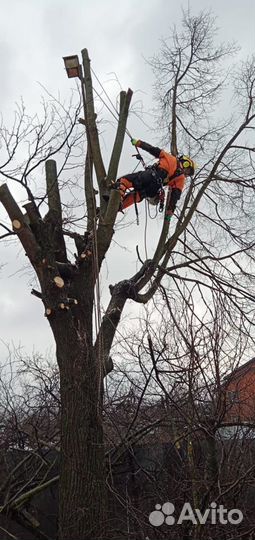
[49,306,105,540]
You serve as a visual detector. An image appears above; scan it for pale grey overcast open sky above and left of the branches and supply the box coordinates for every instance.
[0,0,255,358]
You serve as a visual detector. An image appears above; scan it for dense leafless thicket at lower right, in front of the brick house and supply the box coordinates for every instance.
[106,284,255,539]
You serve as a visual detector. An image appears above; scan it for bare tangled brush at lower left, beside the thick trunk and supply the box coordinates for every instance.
[0,350,60,540]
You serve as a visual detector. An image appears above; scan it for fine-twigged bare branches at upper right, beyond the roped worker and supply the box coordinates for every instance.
[145,11,255,338]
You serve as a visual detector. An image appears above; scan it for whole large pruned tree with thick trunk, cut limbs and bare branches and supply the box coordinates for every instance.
[0,8,255,540]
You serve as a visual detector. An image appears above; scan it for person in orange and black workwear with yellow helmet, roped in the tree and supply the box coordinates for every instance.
[115,139,195,221]
